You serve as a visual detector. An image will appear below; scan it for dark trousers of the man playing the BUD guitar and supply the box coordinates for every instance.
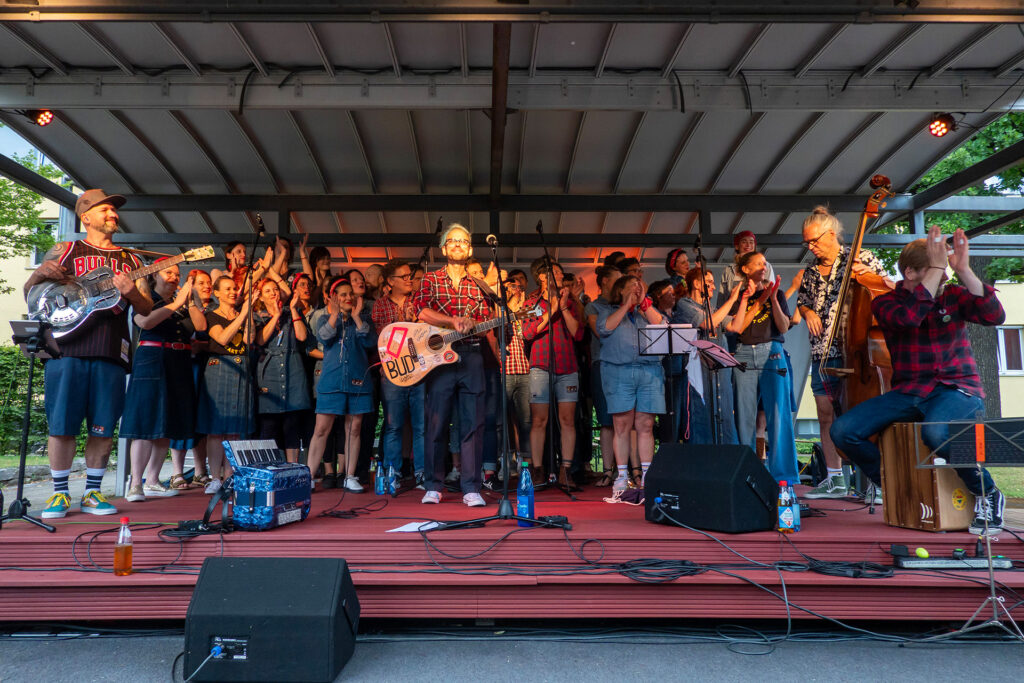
[423,345,484,494]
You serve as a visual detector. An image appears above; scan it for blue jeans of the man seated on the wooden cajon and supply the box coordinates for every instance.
[828,384,995,496]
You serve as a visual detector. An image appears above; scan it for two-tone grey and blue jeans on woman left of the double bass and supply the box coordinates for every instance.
[732,341,800,483]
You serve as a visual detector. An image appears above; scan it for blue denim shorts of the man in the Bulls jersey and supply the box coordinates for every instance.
[43,357,125,438]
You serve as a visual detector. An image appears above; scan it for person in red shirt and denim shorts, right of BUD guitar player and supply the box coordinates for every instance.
[522,257,584,486]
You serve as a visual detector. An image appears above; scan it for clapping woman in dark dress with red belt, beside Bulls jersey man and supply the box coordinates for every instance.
[119,257,206,503]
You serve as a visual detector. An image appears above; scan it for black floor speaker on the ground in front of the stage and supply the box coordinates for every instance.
[183,557,359,683]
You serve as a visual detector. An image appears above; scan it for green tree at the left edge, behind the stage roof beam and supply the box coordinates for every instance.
[0,138,62,294]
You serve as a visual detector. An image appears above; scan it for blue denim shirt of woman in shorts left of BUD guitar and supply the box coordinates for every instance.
[316,312,377,393]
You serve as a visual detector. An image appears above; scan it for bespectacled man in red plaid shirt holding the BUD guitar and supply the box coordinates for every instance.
[413,223,490,507]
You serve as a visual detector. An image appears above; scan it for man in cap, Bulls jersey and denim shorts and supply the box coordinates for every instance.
[25,189,153,519]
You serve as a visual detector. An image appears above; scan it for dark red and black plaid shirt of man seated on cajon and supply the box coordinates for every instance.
[871,282,1006,398]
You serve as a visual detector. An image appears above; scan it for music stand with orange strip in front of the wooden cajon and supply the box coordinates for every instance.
[914,419,1024,642]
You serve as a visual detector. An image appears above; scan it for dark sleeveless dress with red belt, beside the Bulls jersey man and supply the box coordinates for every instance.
[119,293,196,439]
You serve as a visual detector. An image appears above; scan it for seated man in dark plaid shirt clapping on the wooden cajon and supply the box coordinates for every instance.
[830,225,1006,535]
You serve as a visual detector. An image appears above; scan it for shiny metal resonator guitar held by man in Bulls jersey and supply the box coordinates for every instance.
[28,245,214,339]
